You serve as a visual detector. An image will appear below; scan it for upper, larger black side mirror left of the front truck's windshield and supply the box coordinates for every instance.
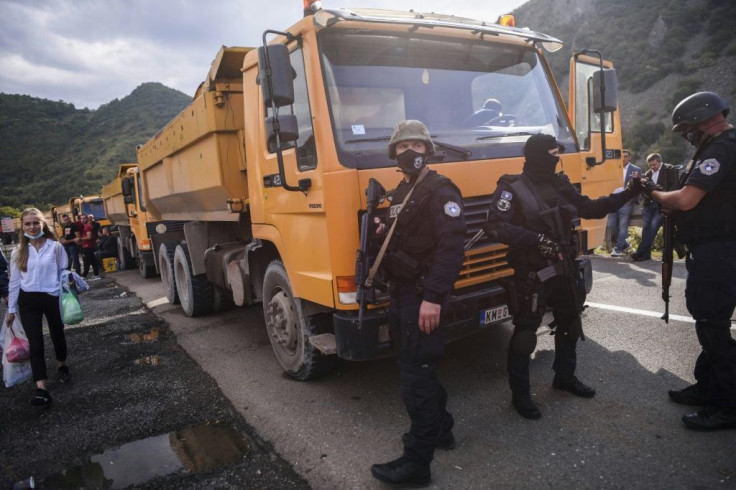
[258,44,296,107]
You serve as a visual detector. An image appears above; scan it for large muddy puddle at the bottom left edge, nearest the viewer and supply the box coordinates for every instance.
[43,424,249,488]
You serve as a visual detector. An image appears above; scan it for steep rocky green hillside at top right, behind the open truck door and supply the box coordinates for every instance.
[513,0,736,166]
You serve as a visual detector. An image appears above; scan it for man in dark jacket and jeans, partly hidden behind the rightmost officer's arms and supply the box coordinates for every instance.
[631,153,678,262]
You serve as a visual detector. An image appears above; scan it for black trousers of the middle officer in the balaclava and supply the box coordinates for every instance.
[506,269,581,395]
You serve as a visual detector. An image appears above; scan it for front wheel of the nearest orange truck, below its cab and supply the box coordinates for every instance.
[263,260,336,381]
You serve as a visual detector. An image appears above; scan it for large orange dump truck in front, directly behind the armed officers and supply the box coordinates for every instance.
[138,1,622,379]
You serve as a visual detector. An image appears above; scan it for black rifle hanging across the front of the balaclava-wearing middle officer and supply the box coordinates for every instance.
[540,208,585,340]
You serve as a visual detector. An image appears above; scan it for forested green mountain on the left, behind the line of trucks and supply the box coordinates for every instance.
[0,83,191,210]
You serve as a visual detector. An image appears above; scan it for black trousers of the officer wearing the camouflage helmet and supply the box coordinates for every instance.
[389,286,455,465]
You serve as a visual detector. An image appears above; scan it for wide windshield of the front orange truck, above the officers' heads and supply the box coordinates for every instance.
[319,28,575,168]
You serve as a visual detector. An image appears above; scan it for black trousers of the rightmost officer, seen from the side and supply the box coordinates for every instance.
[685,241,736,407]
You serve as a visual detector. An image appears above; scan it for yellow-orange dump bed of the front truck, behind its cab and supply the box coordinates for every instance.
[138,46,252,221]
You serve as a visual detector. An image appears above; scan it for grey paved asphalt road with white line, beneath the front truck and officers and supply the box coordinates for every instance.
[115,257,736,489]
